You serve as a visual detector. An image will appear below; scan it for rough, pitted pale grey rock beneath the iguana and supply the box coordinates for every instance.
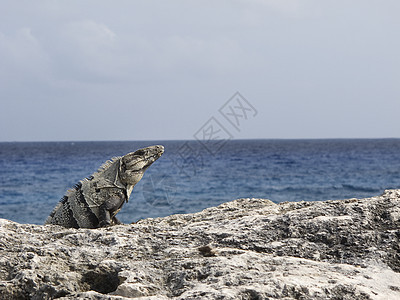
[0,190,400,300]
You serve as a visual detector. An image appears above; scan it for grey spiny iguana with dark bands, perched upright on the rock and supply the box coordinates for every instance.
[45,145,164,228]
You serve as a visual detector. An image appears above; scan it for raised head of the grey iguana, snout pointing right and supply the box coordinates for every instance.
[119,145,164,188]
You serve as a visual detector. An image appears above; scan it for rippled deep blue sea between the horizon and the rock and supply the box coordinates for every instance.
[0,139,400,224]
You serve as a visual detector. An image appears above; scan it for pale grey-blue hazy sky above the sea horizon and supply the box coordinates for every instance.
[0,0,400,141]
